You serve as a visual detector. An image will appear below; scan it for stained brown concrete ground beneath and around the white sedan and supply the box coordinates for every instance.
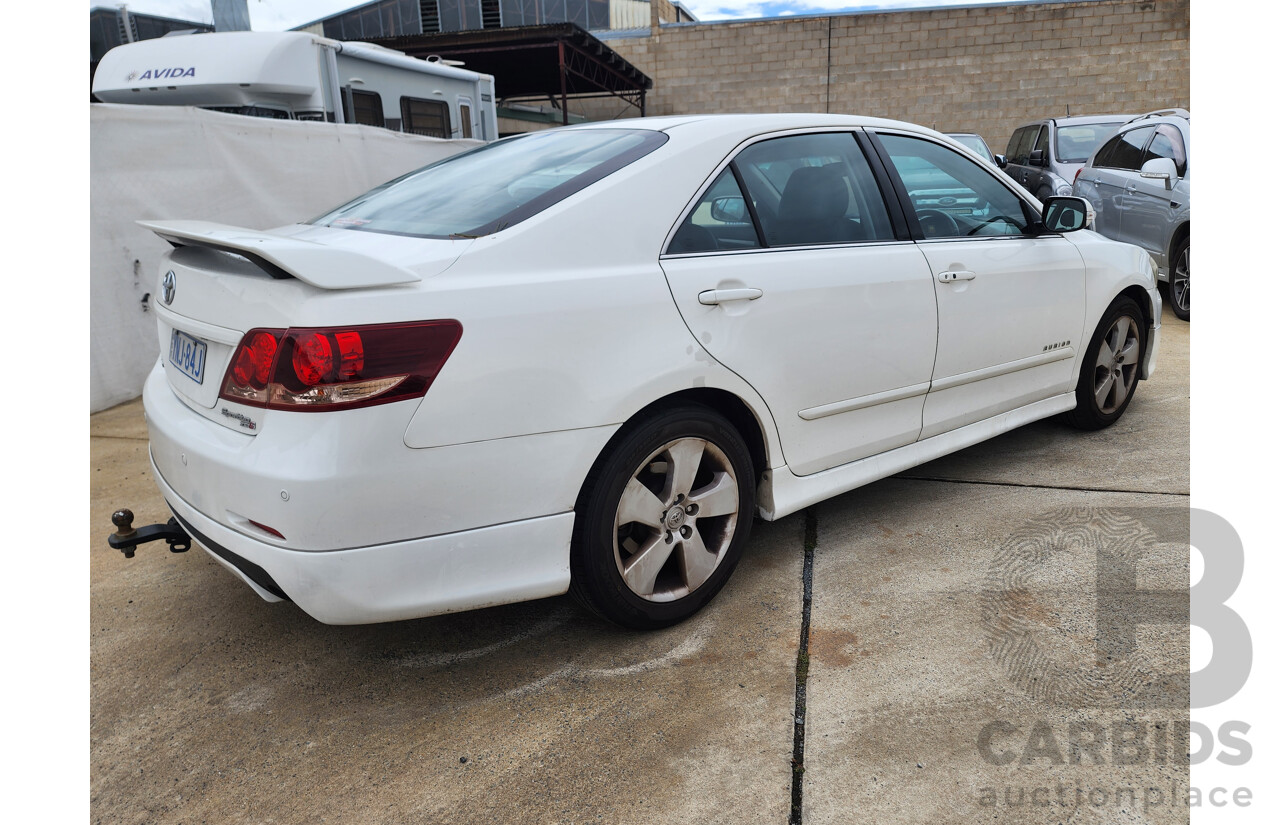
[88,301,1190,825]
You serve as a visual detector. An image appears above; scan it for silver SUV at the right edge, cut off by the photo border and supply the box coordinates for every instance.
[1074,109,1192,321]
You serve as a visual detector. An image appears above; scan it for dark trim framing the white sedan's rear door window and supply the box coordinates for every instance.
[659,127,911,258]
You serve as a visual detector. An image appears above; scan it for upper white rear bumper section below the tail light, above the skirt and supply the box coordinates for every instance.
[143,367,616,553]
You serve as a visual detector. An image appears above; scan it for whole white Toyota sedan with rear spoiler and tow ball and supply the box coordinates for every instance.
[113,115,1160,628]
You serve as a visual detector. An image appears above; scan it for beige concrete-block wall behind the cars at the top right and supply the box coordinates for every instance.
[586,0,1190,152]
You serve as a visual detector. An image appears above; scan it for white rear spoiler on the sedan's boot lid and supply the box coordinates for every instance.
[138,220,422,289]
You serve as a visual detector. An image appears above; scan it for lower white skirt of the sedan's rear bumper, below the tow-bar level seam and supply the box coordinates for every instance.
[151,452,573,624]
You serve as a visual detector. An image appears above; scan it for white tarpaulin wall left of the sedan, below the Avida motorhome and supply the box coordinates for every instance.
[90,104,479,412]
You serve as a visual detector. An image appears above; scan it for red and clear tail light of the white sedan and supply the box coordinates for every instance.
[219,321,462,412]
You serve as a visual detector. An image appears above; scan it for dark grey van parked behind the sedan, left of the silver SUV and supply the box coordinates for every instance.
[1005,115,1133,201]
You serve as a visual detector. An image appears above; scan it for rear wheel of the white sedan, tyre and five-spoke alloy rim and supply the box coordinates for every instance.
[570,404,755,629]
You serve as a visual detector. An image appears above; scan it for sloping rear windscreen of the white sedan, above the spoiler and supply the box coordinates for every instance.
[311,129,667,238]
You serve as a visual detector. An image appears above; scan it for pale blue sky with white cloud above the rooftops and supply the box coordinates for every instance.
[90,0,1029,31]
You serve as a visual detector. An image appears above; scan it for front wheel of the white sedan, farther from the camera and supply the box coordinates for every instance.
[1066,295,1147,430]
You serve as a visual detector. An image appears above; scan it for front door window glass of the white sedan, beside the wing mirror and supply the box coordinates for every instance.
[879,134,1029,239]
